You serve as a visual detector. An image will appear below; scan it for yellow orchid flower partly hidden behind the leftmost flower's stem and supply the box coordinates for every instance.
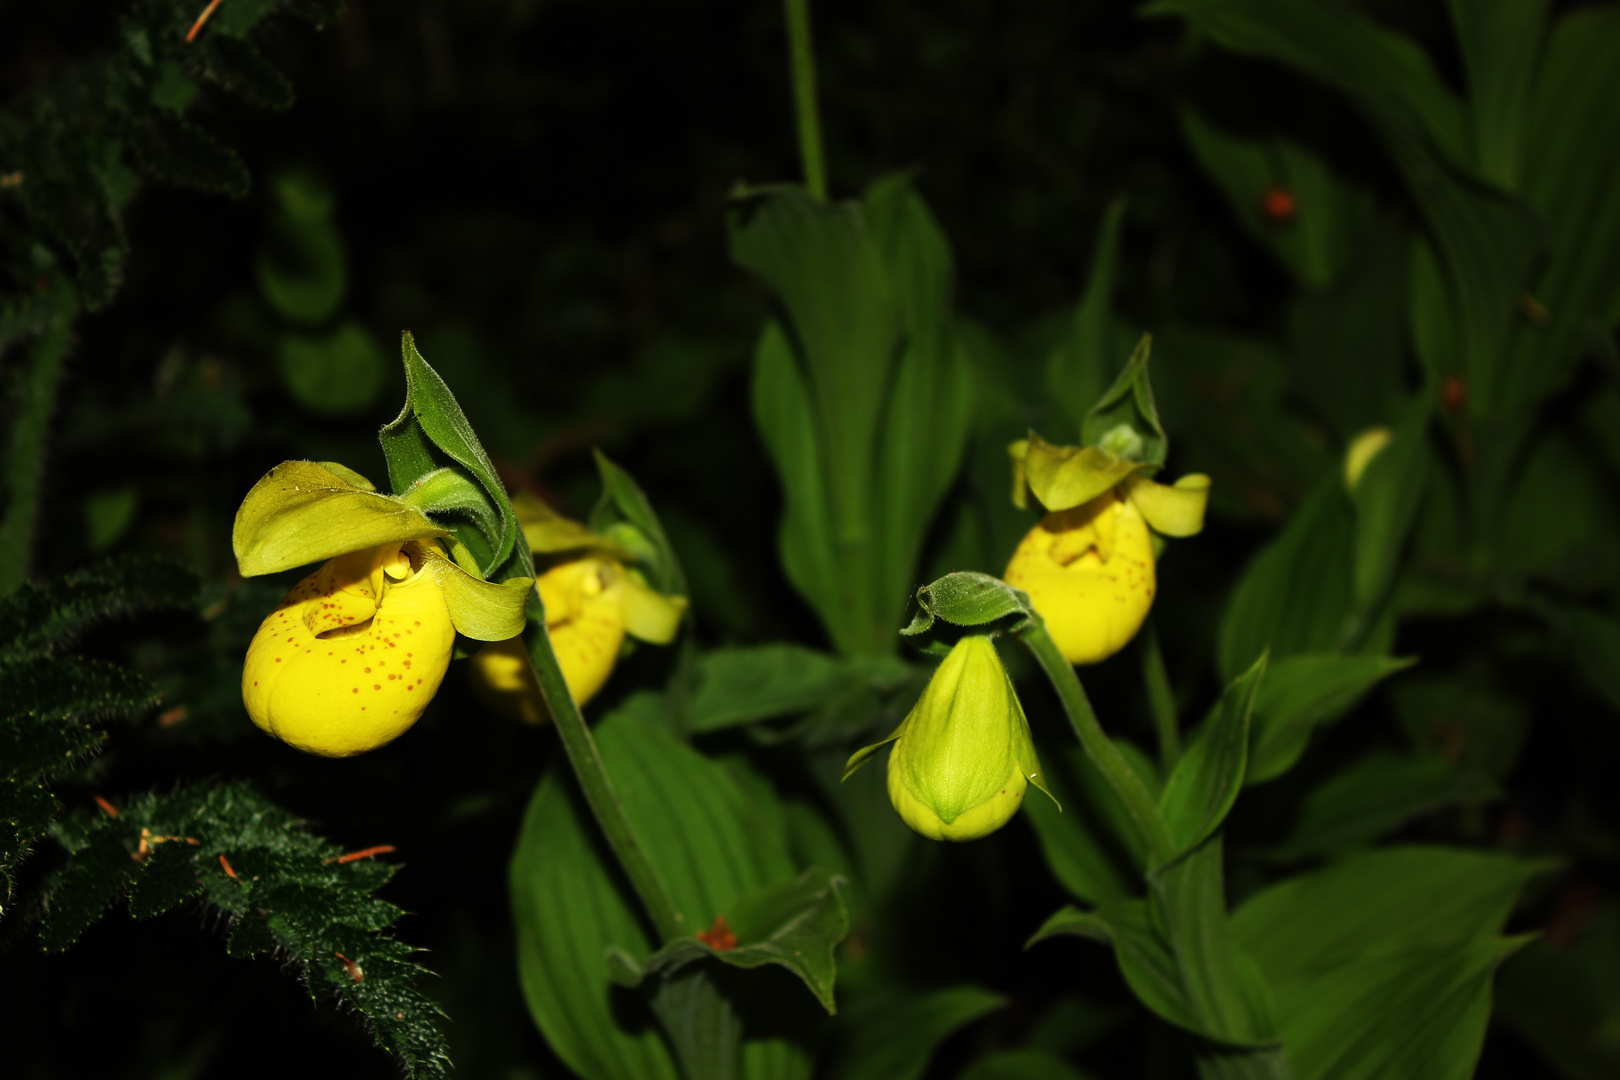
[471,494,687,724]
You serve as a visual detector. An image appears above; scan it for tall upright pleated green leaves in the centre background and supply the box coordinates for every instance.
[731,176,974,654]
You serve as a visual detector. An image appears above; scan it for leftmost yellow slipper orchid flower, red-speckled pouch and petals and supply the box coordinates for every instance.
[232,461,535,758]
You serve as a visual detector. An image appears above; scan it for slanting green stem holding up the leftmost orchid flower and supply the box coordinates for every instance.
[527,589,687,942]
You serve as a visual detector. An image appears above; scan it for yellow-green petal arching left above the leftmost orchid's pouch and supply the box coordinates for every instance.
[230,461,450,579]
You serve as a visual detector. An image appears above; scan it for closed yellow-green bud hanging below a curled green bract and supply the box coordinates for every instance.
[844,636,1056,840]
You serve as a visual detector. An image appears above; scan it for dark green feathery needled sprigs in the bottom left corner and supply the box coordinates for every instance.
[0,557,449,1077]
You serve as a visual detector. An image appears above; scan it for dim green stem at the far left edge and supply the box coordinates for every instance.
[0,283,79,596]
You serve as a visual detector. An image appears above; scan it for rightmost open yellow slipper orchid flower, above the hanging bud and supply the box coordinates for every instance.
[1001,436,1210,664]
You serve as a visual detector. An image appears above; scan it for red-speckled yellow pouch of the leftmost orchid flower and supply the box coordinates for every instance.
[241,542,455,758]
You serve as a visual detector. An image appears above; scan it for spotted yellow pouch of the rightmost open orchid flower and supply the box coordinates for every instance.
[1001,491,1157,664]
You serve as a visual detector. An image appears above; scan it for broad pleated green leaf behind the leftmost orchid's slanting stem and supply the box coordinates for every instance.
[512,711,835,1080]
